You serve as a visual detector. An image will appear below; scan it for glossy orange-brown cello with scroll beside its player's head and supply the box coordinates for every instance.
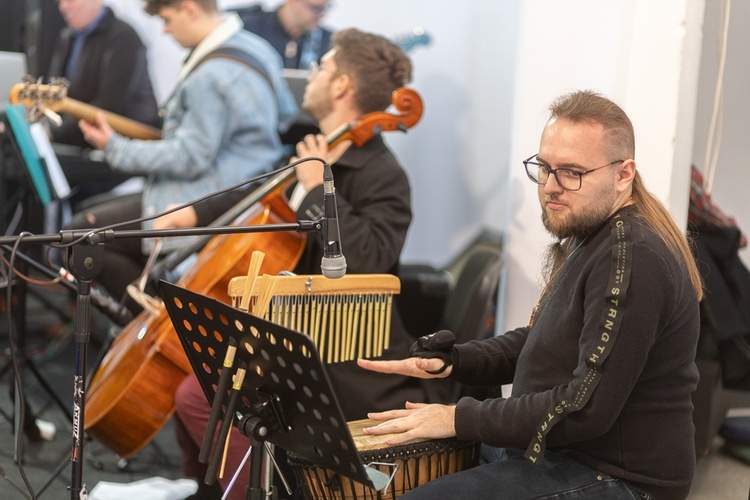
[84,88,422,457]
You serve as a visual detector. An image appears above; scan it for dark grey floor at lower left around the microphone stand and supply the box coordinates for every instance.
[0,284,187,500]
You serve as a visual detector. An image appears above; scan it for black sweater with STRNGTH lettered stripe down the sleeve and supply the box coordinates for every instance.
[453,206,699,498]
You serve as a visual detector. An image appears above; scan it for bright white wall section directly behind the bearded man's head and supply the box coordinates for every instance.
[503,0,703,328]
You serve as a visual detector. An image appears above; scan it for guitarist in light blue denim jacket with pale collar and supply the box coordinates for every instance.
[70,0,297,310]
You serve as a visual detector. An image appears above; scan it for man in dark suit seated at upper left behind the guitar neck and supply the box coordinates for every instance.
[48,0,160,207]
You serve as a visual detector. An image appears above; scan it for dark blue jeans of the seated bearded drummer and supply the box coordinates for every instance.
[401,445,649,500]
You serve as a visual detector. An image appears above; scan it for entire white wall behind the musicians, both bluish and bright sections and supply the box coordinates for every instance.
[103,0,704,336]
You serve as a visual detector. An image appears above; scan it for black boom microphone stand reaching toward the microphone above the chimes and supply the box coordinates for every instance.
[0,221,322,500]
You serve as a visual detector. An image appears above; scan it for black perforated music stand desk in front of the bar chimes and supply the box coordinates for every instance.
[159,280,375,488]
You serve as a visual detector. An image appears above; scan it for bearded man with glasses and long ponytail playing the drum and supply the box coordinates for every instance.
[359,91,703,500]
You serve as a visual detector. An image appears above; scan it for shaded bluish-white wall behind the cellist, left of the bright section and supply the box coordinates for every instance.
[107,0,521,265]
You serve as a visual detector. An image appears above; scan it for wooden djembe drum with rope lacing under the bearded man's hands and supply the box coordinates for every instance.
[287,419,479,500]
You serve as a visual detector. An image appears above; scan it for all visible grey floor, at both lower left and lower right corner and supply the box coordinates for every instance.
[0,286,750,500]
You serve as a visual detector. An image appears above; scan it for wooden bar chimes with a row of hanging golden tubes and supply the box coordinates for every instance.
[229,274,401,363]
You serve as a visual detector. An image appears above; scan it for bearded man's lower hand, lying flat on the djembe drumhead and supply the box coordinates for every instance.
[362,401,456,446]
